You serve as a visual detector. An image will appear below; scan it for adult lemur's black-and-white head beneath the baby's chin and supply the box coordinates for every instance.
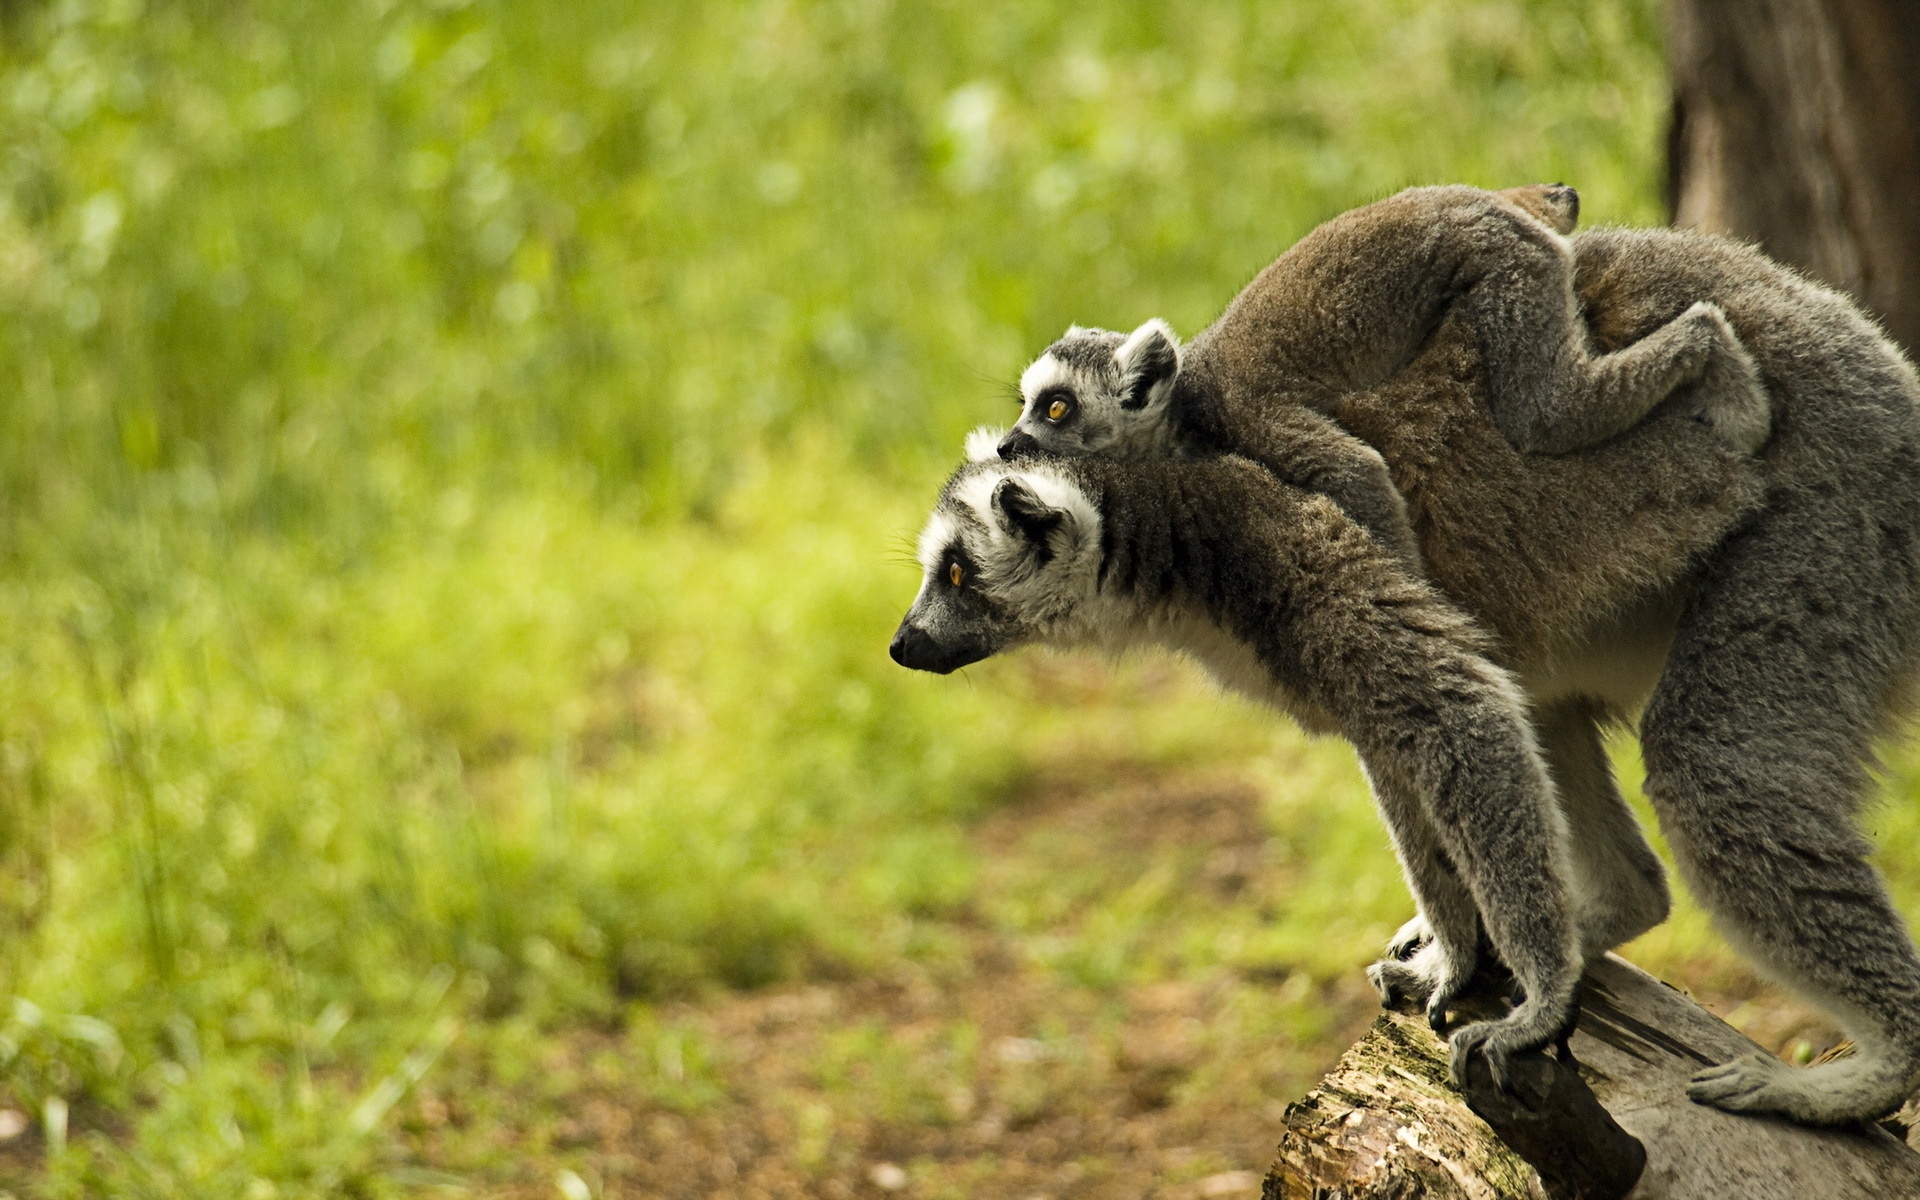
[887,451,1100,674]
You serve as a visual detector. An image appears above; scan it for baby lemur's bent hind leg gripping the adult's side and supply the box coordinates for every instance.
[1463,213,1772,453]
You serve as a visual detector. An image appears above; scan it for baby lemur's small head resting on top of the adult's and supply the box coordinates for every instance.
[1000,319,1181,459]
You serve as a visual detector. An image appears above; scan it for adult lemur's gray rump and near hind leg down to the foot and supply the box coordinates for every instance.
[1578,230,1920,1121]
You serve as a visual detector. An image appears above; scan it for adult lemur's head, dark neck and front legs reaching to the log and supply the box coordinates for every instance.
[891,455,1580,1077]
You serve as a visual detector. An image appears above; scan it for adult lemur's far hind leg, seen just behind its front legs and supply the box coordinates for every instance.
[1534,697,1672,962]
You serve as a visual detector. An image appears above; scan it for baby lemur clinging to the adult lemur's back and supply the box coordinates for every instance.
[1000,184,1768,561]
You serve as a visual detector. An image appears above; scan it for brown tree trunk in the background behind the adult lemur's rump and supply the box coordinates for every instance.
[1667,0,1920,353]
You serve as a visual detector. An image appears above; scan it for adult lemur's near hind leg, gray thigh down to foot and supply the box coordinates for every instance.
[1642,488,1920,1125]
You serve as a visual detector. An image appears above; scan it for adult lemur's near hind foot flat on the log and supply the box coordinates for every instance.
[1686,1052,1914,1125]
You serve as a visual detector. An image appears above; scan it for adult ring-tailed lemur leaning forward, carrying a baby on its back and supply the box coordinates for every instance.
[893,215,1920,1123]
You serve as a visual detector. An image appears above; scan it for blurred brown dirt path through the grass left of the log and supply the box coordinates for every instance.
[409,778,1375,1200]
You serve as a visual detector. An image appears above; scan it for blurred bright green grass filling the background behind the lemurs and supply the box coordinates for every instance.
[0,0,1920,1198]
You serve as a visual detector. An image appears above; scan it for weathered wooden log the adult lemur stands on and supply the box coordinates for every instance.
[1263,954,1920,1200]
